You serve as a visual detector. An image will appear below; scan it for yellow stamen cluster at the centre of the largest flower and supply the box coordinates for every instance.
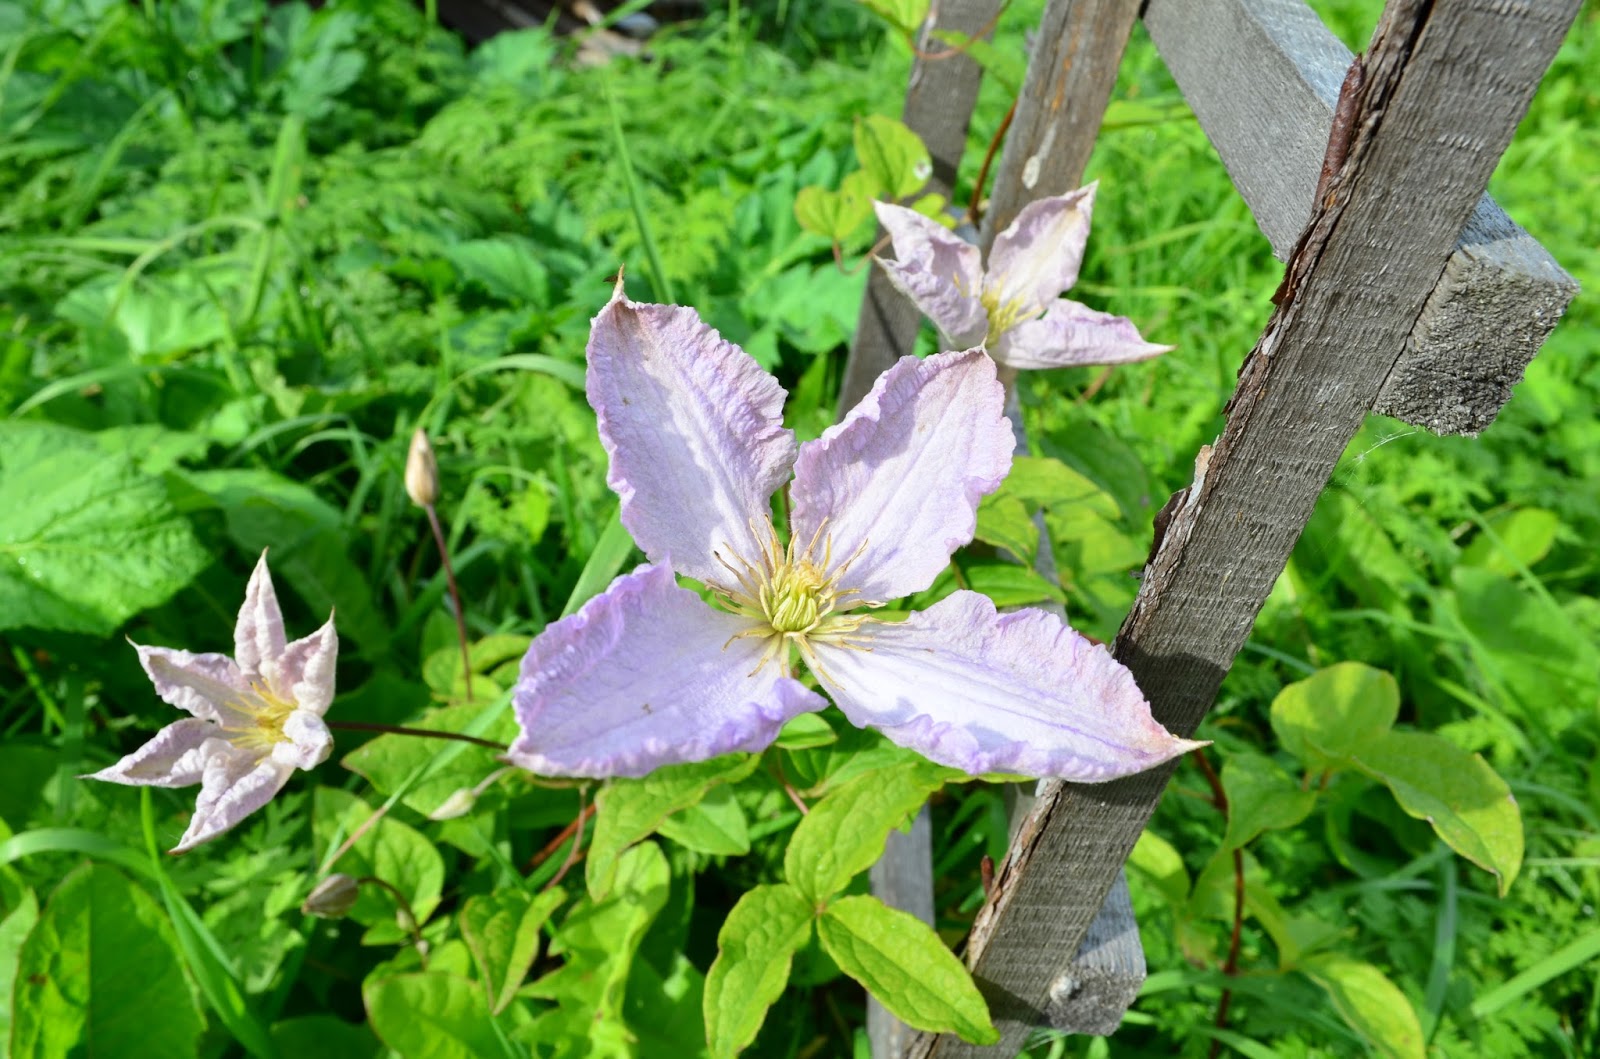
[710,518,874,673]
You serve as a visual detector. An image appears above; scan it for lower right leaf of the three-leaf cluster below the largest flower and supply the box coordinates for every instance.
[816,894,1000,1045]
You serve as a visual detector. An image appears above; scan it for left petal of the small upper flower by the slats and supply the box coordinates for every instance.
[872,202,989,347]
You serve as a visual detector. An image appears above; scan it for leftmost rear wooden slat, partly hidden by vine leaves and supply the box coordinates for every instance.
[838,0,1002,416]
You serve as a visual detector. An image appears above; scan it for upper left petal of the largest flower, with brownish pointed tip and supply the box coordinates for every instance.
[587,282,795,581]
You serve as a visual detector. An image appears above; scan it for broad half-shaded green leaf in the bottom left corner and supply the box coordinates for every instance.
[11,864,203,1059]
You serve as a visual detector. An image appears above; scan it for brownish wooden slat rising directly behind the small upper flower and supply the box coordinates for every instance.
[982,0,1139,244]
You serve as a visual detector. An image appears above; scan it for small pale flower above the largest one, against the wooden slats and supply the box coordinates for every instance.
[872,184,1173,368]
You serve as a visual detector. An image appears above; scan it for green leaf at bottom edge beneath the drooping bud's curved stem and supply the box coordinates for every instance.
[362,971,506,1059]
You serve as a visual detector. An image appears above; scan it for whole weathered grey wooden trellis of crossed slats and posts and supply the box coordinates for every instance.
[845,0,1579,1059]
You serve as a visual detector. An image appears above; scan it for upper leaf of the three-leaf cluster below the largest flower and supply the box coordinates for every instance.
[784,761,963,902]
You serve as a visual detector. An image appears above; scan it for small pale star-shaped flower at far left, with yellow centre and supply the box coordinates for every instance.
[85,552,339,853]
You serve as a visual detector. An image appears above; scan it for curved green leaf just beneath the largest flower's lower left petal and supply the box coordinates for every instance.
[584,753,760,901]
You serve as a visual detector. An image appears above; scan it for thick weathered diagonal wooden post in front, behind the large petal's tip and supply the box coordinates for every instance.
[912,0,1579,1059]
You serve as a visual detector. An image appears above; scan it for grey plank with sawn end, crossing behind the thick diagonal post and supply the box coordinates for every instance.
[1144,0,1578,434]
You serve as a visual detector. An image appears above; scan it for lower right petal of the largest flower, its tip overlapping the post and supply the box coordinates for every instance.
[814,592,1203,782]
